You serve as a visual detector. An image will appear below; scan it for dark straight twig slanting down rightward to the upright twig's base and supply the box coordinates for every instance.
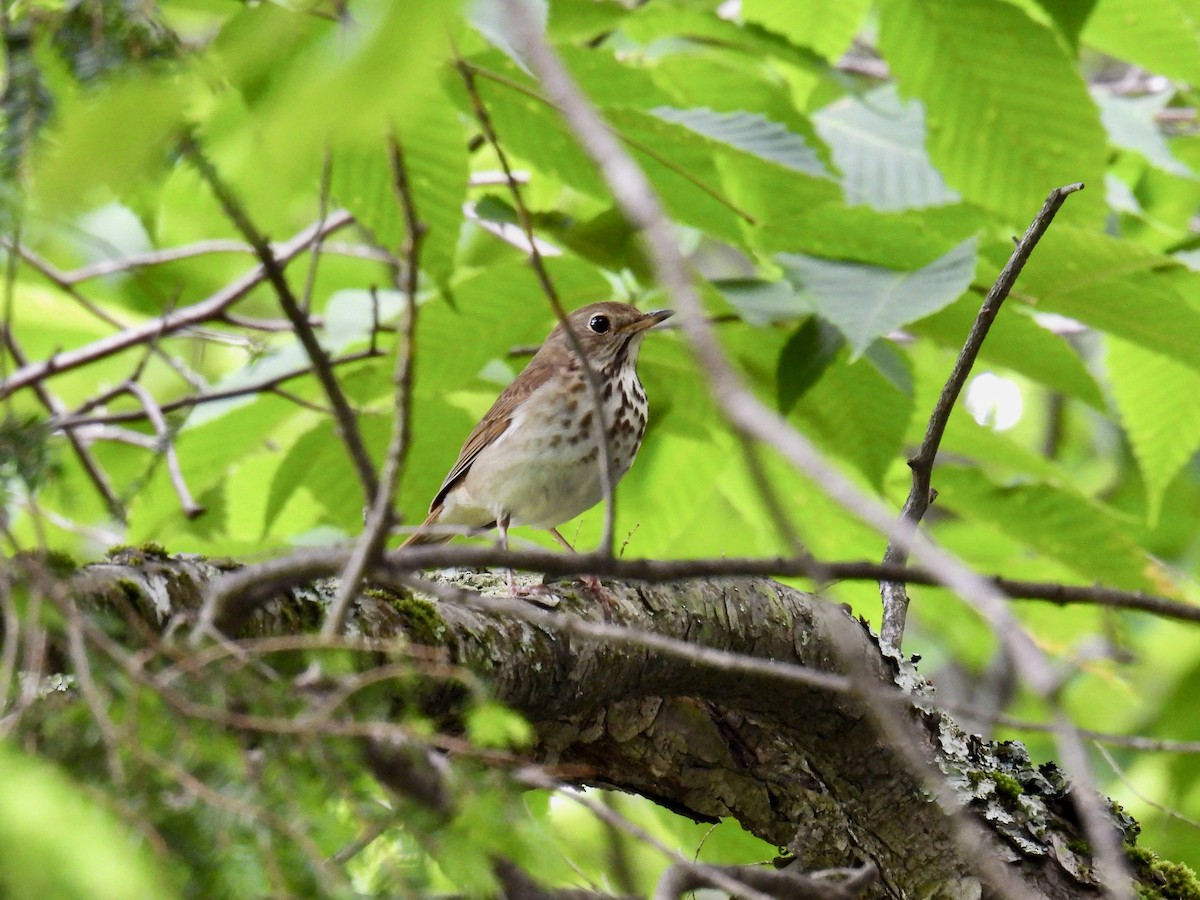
[180,134,379,505]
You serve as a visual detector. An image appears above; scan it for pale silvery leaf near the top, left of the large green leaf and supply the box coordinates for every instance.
[814,84,959,210]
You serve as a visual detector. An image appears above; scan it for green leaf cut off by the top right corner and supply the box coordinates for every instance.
[1082,0,1200,84]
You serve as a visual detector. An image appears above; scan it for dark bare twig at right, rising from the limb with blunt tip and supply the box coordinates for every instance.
[880,182,1084,649]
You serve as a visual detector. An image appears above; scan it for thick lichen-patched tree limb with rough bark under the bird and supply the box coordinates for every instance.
[32,554,1166,898]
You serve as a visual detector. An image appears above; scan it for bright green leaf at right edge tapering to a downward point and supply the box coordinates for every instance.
[1105,335,1200,522]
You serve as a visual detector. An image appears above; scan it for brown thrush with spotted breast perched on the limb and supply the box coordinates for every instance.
[404,302,672,571]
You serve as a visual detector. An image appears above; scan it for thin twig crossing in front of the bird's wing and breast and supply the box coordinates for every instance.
[458,59,617,557]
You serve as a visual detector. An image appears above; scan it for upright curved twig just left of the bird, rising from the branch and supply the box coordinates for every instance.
[322,137,426,636]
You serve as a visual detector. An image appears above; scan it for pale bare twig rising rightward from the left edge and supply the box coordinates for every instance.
[0,211,354,400]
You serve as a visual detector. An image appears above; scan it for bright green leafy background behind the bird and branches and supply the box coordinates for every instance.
[7,0,1200,896]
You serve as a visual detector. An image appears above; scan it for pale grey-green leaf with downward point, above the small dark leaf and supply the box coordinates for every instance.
[776,239,976,359]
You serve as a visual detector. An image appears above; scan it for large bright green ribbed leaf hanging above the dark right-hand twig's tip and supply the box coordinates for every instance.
[880,0,1106,226]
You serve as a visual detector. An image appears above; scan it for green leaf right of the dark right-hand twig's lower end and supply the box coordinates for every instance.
[934,466,1153,590]
